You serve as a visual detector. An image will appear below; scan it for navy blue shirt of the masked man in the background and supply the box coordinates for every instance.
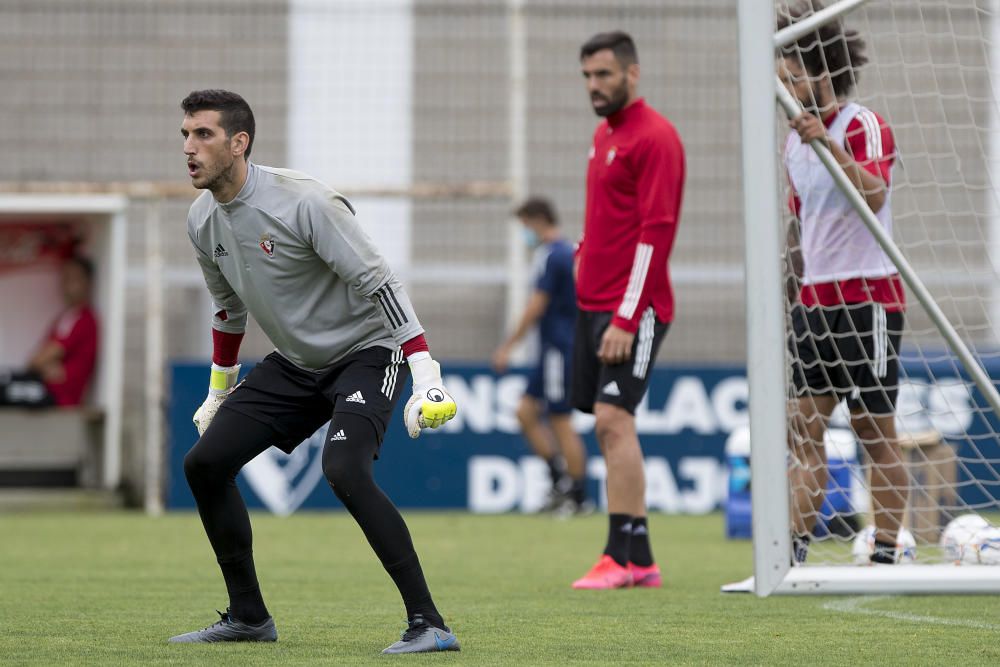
[534,239,576,349]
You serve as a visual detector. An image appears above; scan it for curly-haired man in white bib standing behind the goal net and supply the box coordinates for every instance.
[777,0,908,563]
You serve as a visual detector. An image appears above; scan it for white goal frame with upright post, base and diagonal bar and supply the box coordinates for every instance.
[736,0,1000,596]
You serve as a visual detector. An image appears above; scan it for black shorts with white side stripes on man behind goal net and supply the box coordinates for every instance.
[788,303,904,415]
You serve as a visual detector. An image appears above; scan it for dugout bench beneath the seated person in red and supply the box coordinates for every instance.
[0,407,104,488]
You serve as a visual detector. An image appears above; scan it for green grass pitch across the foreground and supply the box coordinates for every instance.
[0,512,1000,667]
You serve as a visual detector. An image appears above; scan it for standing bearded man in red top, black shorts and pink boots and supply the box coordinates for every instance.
[573,32,684,589]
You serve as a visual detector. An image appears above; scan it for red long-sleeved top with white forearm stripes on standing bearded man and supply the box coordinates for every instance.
[576,98,685,333]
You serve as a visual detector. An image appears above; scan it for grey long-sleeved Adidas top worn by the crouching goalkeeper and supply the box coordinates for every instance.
[188,163,423,370]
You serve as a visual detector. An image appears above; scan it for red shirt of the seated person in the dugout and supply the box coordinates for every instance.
[45,305,97,406]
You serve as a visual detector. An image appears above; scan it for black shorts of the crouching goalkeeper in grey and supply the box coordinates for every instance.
[222,347,410,453]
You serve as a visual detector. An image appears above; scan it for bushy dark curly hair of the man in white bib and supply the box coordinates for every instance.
[777,0,868,97]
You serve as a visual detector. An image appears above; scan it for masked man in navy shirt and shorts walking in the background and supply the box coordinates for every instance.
[493,197,593,516]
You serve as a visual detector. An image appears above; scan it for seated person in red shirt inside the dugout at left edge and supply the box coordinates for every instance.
[0,256,97,407]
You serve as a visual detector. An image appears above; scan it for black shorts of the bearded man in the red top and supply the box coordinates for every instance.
[573,308,670,414]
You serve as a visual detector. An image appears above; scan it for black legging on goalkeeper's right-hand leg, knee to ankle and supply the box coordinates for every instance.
[323,412,444,628]
